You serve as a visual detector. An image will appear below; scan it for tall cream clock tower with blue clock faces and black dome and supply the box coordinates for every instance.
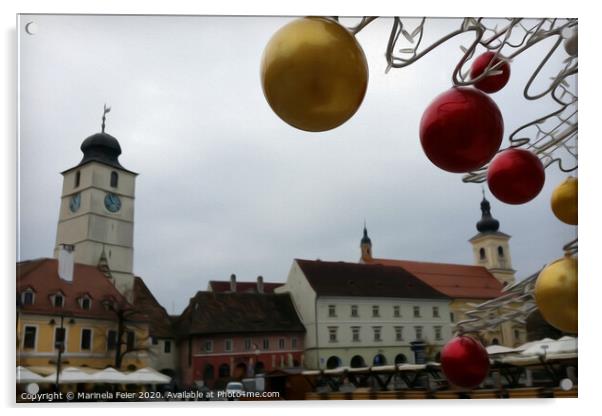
[54,106,137,300]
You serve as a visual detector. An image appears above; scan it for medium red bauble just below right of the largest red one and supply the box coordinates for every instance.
[487,149,546,204]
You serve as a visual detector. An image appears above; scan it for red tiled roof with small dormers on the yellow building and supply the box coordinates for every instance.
[17,258,143,320]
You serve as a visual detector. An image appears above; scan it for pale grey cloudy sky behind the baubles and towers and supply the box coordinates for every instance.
[18,15,576,313]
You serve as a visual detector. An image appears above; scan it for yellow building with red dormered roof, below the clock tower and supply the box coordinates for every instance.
[16,257,150,374]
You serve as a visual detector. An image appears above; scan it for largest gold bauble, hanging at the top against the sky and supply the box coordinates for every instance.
[261,17,368,131]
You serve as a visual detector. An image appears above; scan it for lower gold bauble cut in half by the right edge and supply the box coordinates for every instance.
[535,255,577,333]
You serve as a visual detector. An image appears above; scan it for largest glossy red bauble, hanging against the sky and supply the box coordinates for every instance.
[420,87,504,173]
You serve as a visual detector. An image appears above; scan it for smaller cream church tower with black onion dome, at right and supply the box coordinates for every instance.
[469,193,515,286]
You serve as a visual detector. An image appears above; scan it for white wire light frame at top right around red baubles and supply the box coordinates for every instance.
[349,17,578,183]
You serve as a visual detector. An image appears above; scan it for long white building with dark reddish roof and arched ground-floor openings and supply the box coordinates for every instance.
[275,259,451,369]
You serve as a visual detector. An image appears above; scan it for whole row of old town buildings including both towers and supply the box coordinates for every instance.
[16,117,526,387]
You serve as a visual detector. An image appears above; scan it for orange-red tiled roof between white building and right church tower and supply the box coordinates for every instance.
[369,259,503,299]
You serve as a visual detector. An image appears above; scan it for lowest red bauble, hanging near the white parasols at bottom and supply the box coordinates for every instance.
[441,336,489,388]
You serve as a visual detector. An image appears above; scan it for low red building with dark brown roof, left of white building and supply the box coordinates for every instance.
[174,292,305,388]
